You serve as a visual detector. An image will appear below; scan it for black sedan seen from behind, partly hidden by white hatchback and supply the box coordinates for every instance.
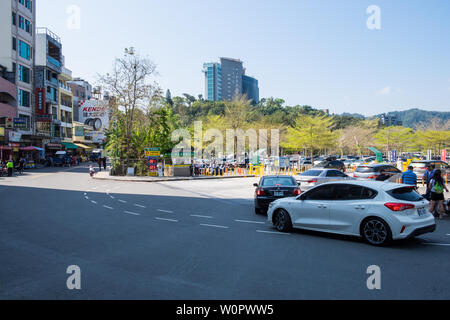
[254,176,301,214]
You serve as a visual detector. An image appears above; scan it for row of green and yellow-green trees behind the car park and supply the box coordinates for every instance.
[100,48,450,165]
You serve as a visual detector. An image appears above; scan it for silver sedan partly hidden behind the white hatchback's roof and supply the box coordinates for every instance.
[294,168,356,191]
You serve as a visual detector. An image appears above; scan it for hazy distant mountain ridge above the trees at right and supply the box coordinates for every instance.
[342,108,450,128]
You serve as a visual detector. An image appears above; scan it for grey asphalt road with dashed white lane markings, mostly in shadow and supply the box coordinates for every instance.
[0,167,450,300]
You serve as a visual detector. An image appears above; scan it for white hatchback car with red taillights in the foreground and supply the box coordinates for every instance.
[268,181,436,245]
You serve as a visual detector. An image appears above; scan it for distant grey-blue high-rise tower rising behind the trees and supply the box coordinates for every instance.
[203,58,259,103]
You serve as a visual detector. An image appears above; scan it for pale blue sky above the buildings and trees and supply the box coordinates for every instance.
[36,0,450,115]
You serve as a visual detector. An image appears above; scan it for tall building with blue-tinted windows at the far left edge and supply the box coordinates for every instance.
[0,0,36,143]
